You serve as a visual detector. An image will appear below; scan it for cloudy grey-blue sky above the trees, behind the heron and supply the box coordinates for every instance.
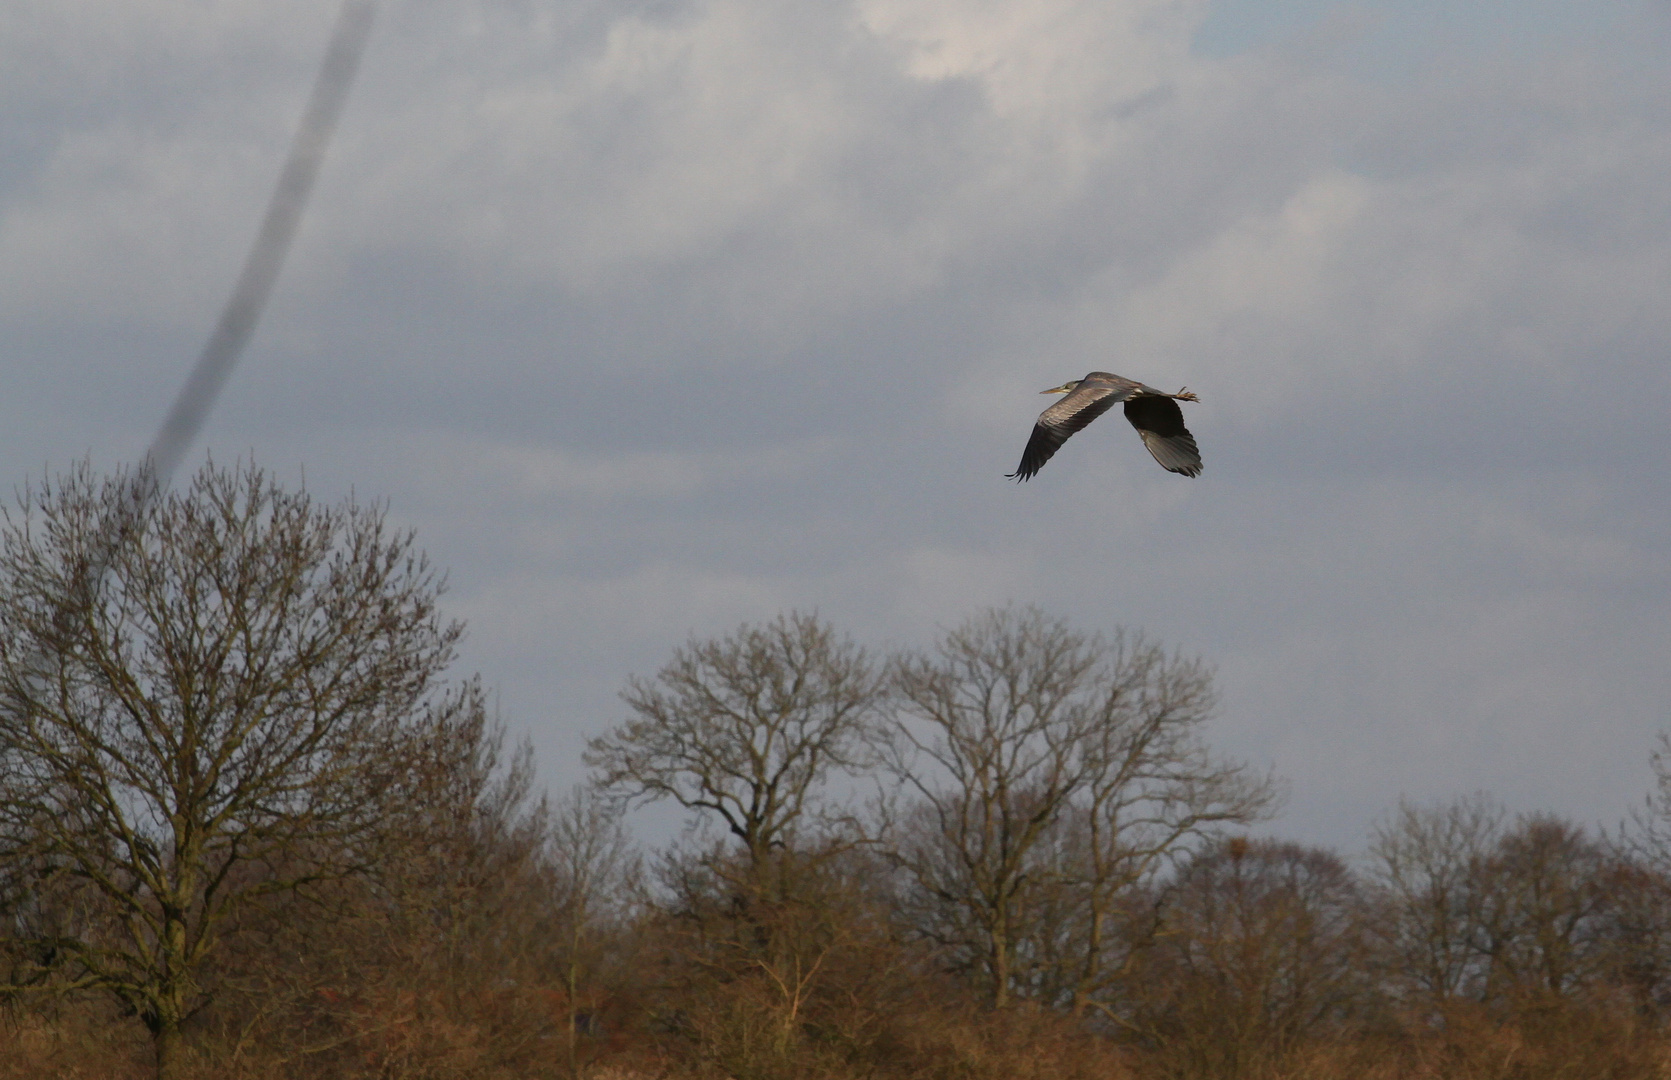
[0,0,1671,848]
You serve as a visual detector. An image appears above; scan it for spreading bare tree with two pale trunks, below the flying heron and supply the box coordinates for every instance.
[887,609,1273,1010]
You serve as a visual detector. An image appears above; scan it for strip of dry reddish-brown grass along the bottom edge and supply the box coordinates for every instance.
[0,990,1671,1080]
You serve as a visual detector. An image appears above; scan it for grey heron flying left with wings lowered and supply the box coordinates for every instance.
[1008,371,1201,480]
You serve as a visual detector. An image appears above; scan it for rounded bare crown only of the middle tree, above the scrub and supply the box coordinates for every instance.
[587,614,879,873]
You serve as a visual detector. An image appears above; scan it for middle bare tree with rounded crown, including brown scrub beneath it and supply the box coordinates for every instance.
[587,614,879,1068]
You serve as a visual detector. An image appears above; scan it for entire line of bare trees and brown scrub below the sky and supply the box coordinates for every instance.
[0,466,1671,1080]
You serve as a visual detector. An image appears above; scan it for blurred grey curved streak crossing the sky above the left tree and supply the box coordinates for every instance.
[140,0,378,490]
